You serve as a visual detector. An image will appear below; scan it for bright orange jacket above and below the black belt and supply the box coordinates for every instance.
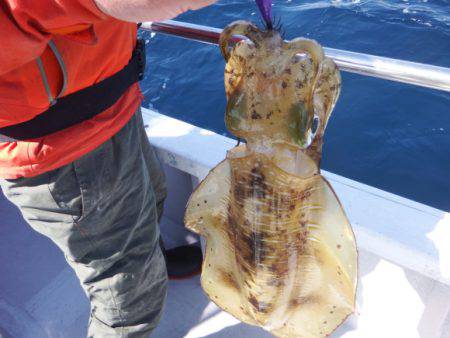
[0,0,142,179]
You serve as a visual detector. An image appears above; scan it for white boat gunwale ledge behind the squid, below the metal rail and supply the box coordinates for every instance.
[142,108,450,286]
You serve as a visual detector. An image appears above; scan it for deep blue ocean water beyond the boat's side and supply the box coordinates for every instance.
[142,0,450,211]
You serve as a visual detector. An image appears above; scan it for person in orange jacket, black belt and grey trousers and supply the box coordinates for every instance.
[0,0,214,337]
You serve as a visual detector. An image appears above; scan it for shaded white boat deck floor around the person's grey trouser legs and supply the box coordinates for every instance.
[0,187,358,338]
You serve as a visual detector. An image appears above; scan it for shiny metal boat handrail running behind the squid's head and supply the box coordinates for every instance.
[141,20,450,92]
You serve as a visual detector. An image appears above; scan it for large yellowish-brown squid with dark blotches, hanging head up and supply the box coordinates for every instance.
[185,21,358,338]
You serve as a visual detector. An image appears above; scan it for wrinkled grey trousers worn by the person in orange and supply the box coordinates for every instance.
[0,112,167,338]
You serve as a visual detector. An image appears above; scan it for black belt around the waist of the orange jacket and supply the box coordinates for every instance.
[0,40,145,142]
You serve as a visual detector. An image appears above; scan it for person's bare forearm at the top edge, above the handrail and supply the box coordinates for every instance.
[94,0,216,22]
